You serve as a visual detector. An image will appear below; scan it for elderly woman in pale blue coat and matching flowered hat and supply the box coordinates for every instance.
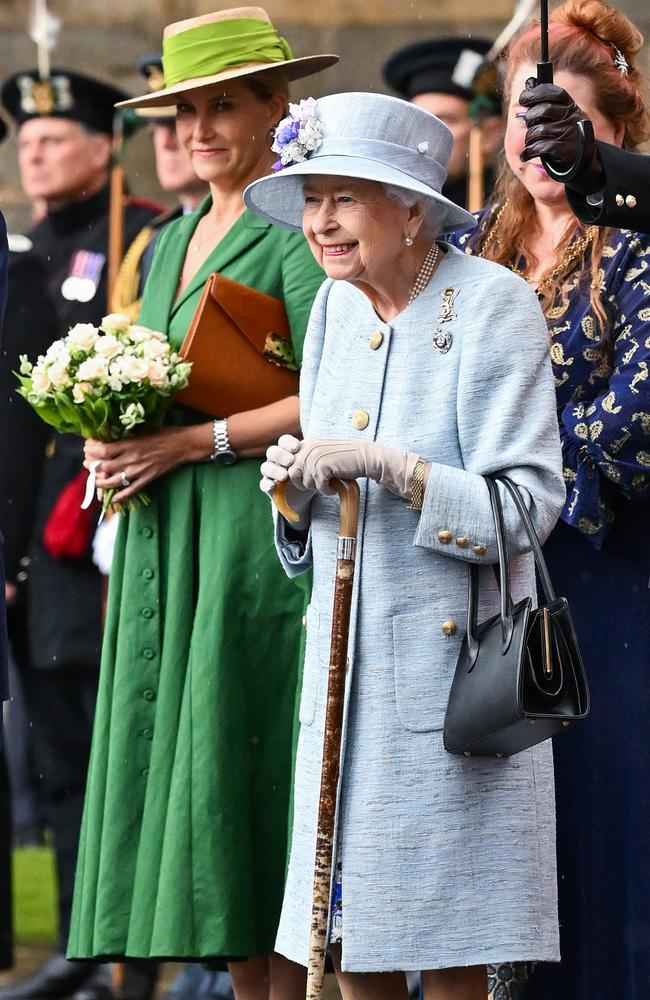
[246,94,564,1000]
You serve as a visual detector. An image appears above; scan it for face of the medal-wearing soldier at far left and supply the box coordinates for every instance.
[18,117,111,206]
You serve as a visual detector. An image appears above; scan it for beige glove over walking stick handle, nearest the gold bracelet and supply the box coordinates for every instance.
[287,438,420,500]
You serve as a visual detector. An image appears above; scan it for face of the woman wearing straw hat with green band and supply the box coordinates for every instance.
[176,79,285,184]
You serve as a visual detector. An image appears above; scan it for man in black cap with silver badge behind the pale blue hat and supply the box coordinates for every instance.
[383,38,503,208]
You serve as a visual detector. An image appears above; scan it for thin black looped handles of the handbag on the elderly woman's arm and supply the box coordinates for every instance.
[467,475,555,670]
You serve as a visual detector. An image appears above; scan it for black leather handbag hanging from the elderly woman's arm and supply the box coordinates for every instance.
[443,476,589,757]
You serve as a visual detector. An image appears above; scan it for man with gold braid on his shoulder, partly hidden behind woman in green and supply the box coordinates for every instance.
[111,54,209,320]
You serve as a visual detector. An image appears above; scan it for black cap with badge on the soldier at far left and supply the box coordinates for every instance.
[0,67,128,135]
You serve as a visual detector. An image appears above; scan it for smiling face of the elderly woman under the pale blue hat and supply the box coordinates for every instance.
[302,175,421,288]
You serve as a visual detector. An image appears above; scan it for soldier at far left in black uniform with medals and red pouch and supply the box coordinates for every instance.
[0,69,160,1000]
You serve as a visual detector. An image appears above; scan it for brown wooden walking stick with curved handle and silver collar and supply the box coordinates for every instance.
[273,479,359,1000]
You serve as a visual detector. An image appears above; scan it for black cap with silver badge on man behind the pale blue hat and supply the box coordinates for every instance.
[383,37,501,115]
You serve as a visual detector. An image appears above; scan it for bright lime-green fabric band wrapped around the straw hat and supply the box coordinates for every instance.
[163,17,292,87]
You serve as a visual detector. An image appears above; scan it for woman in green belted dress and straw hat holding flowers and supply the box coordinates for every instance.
[69,8,335,1000]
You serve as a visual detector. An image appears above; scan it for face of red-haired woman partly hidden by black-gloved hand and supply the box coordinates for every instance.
[505,63,623,205]
